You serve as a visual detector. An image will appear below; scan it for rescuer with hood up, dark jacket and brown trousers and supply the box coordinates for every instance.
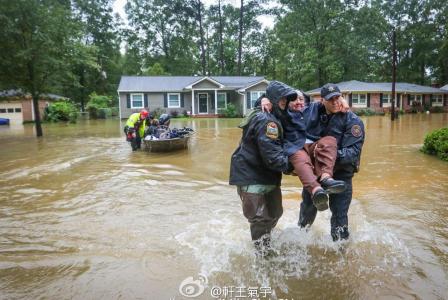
[229,81,297,255]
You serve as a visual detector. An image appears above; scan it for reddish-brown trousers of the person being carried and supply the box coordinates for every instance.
[289,136,338,193]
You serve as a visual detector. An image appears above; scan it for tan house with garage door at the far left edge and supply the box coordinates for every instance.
[0,90,66,124]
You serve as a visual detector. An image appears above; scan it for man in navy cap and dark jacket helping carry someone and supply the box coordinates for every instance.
[299,84,365,241]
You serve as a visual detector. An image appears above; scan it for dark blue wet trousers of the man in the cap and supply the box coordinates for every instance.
[299,173,353,241]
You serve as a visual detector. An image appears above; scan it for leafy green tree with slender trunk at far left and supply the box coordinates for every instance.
[0,0,87,137]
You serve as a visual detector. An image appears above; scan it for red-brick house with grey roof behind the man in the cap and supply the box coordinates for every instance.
[307,80,448,111]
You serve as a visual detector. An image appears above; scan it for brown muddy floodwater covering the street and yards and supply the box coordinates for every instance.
[0,114,448,299]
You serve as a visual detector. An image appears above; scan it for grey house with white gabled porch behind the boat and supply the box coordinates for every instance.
[117,76,268,118]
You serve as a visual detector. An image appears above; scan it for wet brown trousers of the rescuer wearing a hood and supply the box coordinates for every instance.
[237,187,283,241]
